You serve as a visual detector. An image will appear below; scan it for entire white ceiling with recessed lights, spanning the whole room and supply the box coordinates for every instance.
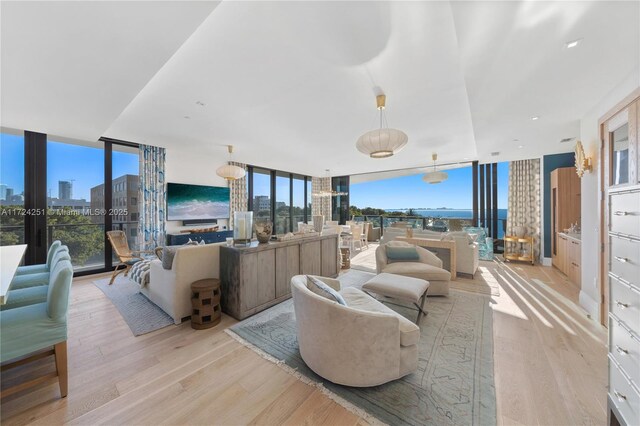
[0,1,640,175]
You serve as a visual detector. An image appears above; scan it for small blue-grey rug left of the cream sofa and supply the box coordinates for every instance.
[93,275,173,336]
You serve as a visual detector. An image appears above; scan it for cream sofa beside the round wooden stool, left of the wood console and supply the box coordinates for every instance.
[146,243,225,324]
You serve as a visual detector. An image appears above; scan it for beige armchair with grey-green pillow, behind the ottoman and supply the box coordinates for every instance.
[376,241,451,296]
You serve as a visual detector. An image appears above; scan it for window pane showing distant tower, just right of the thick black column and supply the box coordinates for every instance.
[47,136,105,270]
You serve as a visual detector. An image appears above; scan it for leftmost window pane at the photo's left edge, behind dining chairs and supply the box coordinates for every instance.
[0,132,25,246]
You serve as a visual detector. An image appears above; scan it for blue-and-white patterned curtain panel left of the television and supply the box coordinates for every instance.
[138,145,166,250]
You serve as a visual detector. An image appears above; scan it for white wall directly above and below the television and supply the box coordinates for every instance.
[165,148,228,234]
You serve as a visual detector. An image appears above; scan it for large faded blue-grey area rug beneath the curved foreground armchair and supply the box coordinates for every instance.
[230,271,496,425]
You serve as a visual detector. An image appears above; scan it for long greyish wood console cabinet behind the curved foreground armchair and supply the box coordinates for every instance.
[220,235,340,320]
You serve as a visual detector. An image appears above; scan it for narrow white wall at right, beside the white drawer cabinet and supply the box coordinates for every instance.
[580,68,640,319]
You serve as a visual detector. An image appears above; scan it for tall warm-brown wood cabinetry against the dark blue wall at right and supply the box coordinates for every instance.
[551,167,580,271]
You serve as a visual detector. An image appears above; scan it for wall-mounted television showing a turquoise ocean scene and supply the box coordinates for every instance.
[167,183,230,220]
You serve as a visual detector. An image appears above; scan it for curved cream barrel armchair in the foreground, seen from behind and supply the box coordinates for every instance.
[291,275,420,387]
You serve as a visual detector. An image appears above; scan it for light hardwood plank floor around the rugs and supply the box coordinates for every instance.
[0,251,607,425]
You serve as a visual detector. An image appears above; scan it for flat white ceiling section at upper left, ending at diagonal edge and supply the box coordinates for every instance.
[0,1,217,141]
